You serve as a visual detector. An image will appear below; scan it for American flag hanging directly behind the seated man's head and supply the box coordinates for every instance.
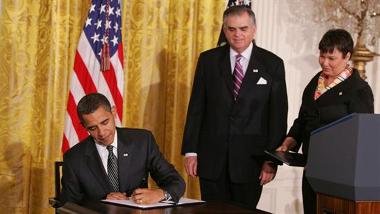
[62,0,124,152]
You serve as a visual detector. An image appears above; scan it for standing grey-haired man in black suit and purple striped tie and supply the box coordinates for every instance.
[182,6,288,209]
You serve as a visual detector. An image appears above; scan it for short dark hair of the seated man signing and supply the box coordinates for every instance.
[77,93,111,124]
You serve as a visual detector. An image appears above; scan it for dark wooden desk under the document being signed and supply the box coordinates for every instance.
[57,202,268,214]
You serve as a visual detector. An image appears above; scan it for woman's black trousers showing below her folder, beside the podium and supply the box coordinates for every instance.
[302,170,317,214]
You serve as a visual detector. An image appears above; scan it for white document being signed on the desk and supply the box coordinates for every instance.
[101,198,205,209]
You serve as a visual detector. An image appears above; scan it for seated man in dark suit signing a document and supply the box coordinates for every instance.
[60,93,185,204]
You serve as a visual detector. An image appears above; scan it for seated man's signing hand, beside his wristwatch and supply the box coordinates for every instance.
[131,188,165,204]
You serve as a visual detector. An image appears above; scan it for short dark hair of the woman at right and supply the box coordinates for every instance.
[319,29,354,57]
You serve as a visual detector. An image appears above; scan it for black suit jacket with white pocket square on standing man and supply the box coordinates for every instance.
[182,45,288,182]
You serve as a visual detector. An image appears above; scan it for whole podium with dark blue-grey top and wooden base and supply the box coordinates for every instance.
[306,114,380,214]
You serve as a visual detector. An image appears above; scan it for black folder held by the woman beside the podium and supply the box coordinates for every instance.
[265,150,306,167]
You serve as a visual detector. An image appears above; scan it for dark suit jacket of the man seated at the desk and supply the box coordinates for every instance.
[60,128,185,202]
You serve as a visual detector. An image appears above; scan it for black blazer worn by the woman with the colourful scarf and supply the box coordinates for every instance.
[288,70,374,158]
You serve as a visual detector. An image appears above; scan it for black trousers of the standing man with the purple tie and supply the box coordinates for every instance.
[199,163,262,209]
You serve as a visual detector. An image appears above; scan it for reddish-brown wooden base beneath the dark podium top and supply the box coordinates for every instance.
[317,193,380,214]
